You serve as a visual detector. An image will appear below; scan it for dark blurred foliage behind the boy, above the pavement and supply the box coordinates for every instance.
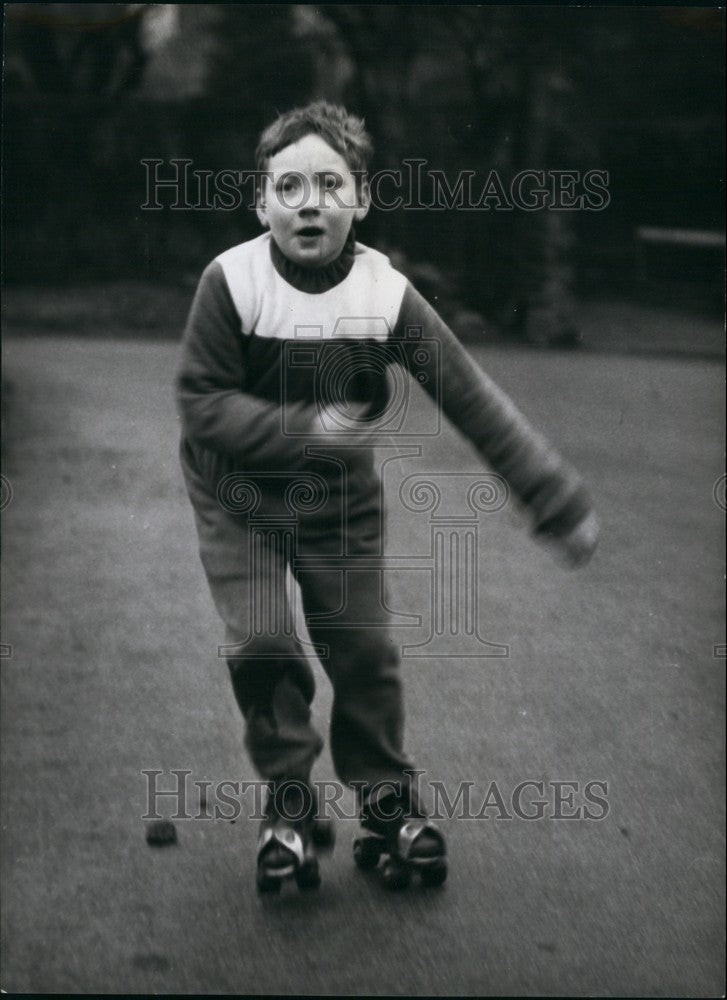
[3,4,724,339]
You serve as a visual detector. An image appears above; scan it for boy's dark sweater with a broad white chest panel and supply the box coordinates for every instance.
[176,233,590,537]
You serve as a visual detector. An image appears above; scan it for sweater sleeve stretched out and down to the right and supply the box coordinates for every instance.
[393,284,591,537]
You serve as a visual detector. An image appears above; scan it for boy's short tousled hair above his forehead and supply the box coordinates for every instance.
[255,101,373,173]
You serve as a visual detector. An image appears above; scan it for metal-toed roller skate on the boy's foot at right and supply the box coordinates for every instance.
[353,791,447,889]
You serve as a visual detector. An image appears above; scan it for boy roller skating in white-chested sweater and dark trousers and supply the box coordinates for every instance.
[177,102,597,891]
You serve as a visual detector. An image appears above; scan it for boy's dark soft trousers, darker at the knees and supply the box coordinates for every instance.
[183,450,412,787]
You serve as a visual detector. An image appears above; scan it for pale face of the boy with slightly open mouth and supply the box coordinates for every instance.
[257,134,369,267]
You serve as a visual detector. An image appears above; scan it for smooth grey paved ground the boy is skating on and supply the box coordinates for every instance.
[1,337,725,996]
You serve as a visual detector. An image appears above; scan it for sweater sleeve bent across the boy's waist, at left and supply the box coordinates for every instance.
[176,261,310,470]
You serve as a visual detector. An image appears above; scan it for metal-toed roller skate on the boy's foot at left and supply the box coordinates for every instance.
[257,781,335,894]
